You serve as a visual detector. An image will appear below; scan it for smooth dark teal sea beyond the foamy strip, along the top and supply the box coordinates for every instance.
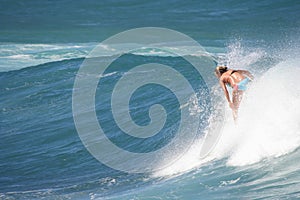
[0,0,299,45]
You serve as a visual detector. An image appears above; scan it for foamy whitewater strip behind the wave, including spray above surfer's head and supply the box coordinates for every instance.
[0,41,274,72]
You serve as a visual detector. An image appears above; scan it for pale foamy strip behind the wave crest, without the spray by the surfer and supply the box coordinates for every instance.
[0,43,223,72]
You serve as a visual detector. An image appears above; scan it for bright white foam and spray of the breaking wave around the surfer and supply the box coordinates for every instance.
[154,38,300,176]
